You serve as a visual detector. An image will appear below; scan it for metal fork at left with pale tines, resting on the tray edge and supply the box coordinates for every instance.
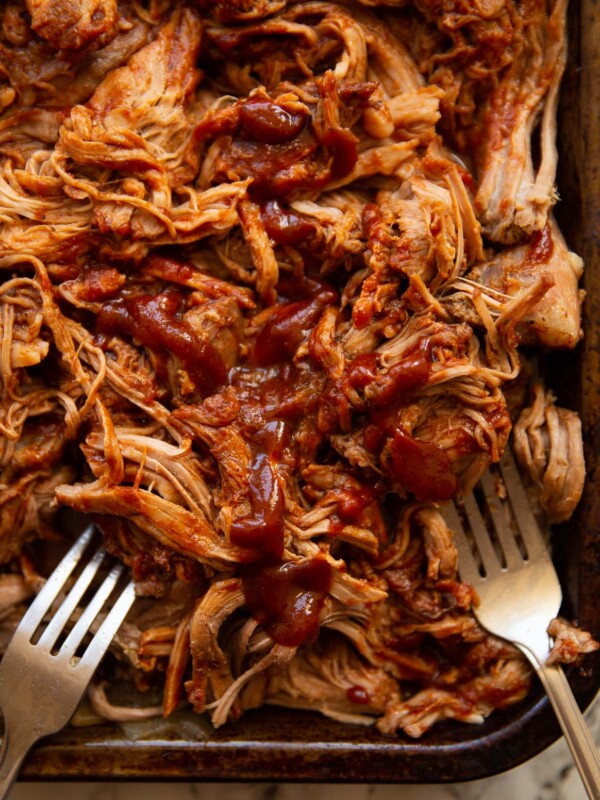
[0,526,135,800]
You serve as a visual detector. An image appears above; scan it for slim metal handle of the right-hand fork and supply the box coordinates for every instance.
[521,647,600,800]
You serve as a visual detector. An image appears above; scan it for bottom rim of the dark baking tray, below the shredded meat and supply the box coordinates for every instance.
[16,675,596,784]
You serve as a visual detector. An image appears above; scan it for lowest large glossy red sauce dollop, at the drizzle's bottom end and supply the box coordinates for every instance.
[242,556,332,647]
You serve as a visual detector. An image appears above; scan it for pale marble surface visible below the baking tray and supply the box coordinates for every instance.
[11,697,600,800]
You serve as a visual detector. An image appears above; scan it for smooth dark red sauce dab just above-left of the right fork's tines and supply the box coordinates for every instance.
[390,429,459,501]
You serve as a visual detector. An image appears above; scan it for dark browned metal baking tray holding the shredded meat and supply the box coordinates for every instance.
[16,0,600,783]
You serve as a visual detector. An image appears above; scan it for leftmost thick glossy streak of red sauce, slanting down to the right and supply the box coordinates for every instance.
[97,292,227,394]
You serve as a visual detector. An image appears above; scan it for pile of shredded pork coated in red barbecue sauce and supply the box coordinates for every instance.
[0,0,593,736]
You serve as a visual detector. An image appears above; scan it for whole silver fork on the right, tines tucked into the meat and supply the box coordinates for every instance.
[441,453,600,800]
